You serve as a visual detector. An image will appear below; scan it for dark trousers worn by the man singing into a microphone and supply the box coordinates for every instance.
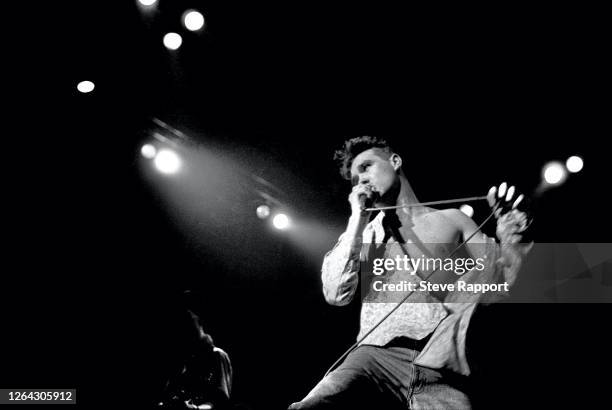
[289,343,470,410]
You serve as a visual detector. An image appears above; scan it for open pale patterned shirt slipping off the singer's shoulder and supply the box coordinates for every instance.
[322,212,503,375]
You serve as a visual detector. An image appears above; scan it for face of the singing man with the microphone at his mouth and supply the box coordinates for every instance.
[351,148,399,196]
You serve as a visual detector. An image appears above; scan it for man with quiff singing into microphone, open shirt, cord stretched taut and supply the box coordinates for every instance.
[290,137,528,410]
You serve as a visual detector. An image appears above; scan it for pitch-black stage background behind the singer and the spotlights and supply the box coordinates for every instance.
[0,0,611,409]
